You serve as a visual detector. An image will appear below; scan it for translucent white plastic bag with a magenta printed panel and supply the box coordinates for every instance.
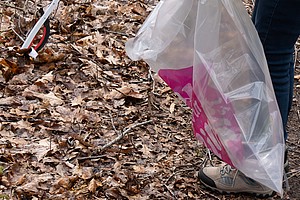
[126,0,285,194]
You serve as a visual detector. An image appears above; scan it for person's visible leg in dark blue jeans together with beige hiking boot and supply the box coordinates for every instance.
[199,0,300,195]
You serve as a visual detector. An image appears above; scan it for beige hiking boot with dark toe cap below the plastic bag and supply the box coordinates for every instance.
[199,165,275,197]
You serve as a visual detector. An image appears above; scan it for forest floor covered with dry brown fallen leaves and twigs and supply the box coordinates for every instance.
[0,0,300,199]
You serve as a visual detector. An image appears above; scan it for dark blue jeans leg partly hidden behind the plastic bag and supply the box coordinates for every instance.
[252,0,300,139]
